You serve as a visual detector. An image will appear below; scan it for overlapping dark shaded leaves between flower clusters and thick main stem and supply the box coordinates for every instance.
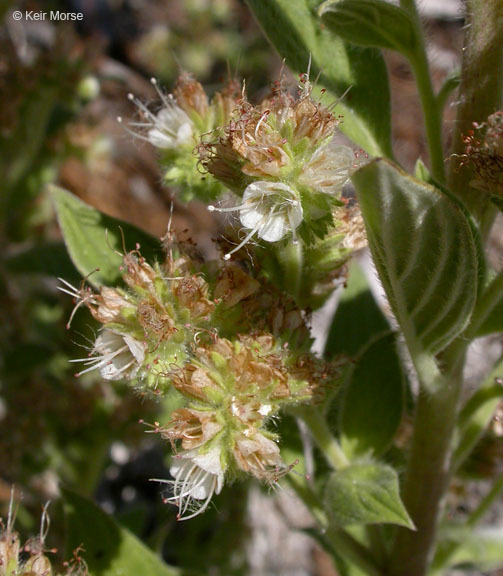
[325,261,405,458]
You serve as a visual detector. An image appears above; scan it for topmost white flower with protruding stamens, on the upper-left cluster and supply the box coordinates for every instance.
[128,78,193,150]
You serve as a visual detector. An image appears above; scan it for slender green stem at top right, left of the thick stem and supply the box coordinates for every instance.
[400,0,445,184]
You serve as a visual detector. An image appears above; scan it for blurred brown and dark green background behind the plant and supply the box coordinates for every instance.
[0,0,503,576]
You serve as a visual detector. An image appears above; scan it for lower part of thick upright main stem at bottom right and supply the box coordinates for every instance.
[389,343,464,576]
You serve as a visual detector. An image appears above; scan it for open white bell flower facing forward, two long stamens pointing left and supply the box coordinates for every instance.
[208,181,303,260]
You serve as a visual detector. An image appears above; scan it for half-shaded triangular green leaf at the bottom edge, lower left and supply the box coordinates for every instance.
[63,490,180,576]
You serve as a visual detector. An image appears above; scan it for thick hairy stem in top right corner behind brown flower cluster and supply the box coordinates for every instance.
[449,0,503,220]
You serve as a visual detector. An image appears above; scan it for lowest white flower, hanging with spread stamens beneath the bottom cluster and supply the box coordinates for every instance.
[152,446,224,520]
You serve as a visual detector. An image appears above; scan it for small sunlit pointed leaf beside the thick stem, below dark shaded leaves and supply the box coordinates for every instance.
[325,463,414,529]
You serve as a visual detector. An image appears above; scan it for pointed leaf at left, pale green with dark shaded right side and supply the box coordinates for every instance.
[51,186,161,286]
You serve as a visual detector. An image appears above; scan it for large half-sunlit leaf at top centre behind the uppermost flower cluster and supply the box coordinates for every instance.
[247,0,393,157]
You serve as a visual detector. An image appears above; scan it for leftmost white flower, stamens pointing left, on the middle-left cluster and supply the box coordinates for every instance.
[70,328,145,380]
